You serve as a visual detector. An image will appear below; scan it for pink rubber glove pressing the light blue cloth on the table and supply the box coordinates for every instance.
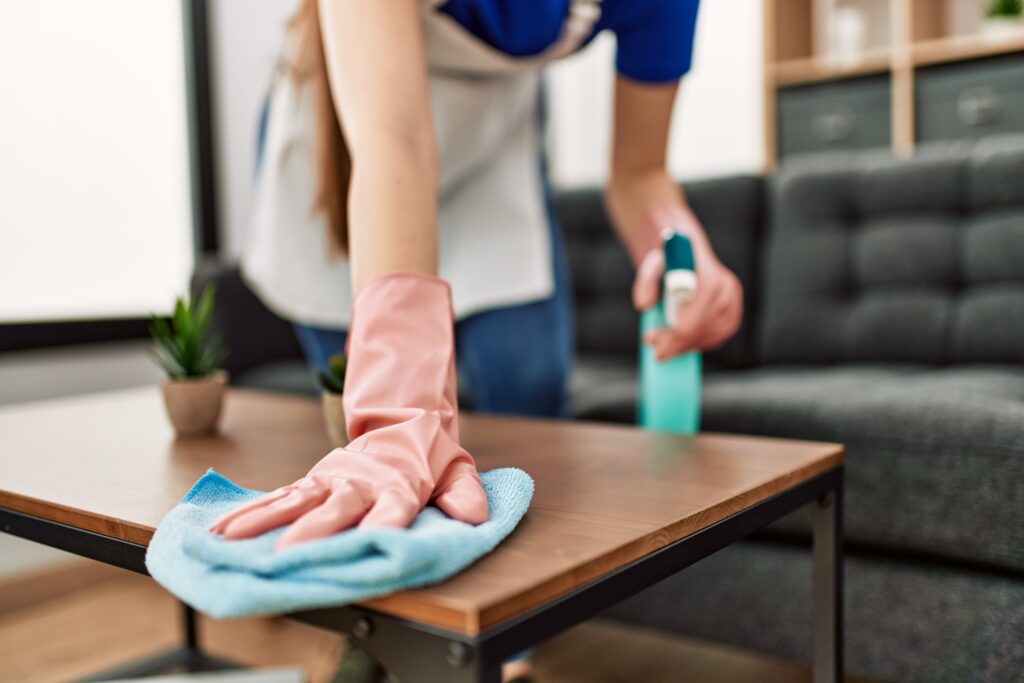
[210,273,487,550]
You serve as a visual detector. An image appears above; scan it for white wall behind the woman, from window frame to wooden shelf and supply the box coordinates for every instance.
[212,0,764,255]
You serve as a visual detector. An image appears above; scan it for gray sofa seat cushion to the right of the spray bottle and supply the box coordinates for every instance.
[701,364,1024,571]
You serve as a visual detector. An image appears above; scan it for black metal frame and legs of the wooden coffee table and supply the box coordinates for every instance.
[0,466,843,683]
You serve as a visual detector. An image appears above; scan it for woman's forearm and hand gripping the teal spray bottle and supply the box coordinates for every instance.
[605,76,743,358]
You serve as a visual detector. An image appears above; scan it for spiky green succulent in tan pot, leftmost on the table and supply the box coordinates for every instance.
[150,287,227,436]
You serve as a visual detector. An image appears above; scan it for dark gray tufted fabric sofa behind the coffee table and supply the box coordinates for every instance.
[194,136,1024,681]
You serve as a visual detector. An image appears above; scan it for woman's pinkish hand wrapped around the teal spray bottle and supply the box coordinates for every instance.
[633,206,743,360]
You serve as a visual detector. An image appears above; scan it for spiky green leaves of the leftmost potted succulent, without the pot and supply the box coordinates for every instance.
[150,286,227,380]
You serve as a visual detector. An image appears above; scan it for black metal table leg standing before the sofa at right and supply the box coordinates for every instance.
[809,478,843,683]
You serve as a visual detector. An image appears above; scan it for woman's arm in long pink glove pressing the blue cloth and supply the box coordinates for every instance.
[210,0,488,550]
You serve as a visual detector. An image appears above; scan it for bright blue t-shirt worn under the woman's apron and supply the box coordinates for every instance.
[440,0,699,83]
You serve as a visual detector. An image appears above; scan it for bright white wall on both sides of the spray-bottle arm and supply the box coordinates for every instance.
[548,0,765,186]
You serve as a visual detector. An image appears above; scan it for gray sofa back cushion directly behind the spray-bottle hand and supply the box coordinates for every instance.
[556,176,764,367]
